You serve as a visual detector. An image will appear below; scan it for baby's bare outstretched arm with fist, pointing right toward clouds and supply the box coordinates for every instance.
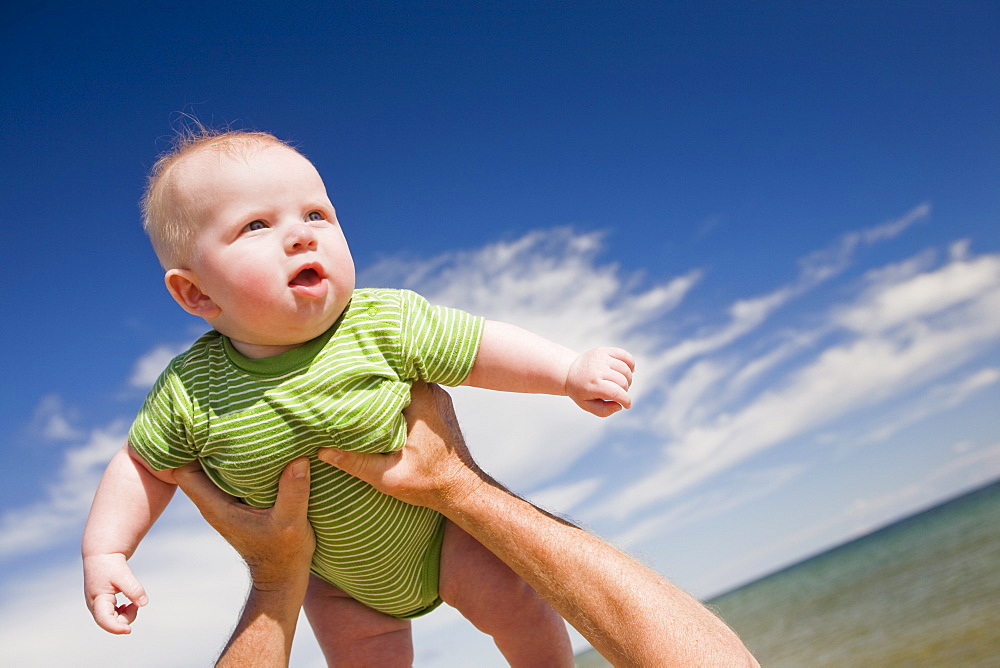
[465,320,635,417]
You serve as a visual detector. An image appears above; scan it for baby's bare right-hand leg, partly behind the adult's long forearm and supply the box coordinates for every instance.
[440,522,573,668]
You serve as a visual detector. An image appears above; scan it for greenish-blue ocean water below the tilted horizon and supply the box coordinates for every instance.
[578,481,1000,668]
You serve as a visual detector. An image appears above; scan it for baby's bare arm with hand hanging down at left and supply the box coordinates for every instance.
[82,444,177,634]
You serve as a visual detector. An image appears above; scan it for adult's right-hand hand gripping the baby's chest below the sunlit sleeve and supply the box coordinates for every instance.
[319,383,486,510]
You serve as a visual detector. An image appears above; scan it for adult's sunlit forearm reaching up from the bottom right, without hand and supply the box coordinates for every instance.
[438,484,756,666]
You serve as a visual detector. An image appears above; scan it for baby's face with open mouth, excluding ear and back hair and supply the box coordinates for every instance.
[177,146,354,356]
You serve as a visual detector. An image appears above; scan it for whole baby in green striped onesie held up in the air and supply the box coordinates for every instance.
[83,132,633,666]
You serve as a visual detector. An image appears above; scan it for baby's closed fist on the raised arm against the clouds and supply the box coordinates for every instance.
[566,348,635,417]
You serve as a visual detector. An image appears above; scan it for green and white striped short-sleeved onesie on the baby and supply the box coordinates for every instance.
[129,289,483,617]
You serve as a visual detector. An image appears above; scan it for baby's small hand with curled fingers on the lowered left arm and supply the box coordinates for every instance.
[83,554,149,635]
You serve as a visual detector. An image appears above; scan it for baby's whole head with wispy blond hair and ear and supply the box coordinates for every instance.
[142,132,354,357]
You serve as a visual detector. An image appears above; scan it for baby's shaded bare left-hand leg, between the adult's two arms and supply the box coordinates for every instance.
[303,575,413,668]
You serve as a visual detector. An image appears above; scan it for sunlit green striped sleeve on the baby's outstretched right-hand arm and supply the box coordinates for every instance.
[400,290,484,386]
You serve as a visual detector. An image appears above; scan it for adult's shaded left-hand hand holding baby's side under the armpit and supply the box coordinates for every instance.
[174,458,316,590]
